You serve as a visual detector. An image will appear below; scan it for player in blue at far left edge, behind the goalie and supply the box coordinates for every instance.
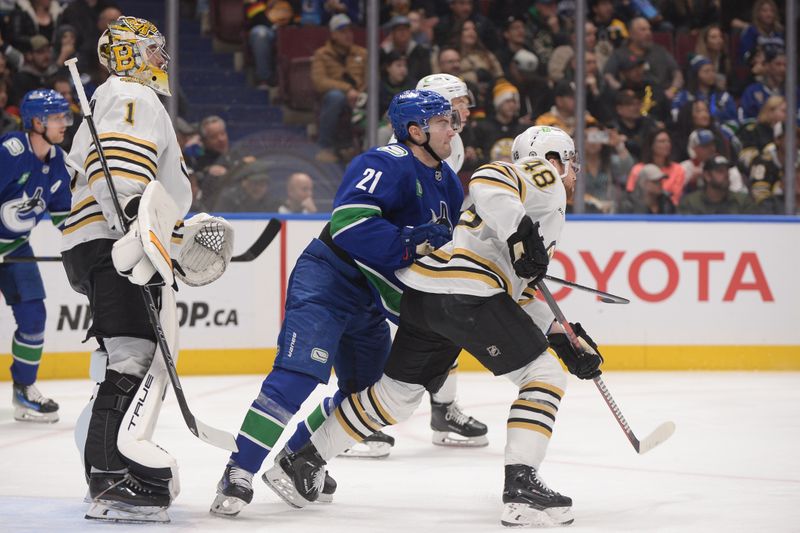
[0,90,72,422]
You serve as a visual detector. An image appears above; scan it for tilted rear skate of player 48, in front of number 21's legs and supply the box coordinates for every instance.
[261,443,326,509]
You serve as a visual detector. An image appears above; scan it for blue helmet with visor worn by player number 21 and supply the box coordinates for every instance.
[388,89,460,142]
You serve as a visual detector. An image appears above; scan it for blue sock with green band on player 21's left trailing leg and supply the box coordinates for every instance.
[231,368,319,473]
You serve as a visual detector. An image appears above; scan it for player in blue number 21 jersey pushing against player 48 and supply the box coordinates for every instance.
[211,90,463,516]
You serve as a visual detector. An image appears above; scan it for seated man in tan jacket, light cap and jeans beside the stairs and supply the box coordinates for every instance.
[311,14,367,162]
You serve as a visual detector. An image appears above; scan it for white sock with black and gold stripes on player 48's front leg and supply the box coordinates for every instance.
[505,352,567,469]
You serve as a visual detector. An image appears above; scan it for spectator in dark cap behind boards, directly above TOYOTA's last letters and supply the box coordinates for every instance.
[678,155,754,215]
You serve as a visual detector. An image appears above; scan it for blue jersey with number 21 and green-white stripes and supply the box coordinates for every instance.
[331,144,464,322]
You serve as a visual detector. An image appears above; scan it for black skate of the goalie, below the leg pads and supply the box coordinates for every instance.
[86,472,172,523]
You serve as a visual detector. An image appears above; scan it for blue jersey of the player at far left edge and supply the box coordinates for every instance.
[0,132,70,255]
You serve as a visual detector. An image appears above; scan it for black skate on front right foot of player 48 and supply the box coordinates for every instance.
[500,465,573,527]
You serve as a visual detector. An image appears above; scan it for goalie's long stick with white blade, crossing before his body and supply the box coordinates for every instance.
[64,58,238,452]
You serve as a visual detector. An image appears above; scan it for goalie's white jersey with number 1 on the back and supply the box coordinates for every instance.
[61,75,192,251]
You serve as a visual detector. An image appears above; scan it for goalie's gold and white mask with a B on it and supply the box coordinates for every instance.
[97,17,171,96]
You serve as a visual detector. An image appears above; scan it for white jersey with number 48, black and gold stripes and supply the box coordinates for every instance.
[397,158,567,304]
